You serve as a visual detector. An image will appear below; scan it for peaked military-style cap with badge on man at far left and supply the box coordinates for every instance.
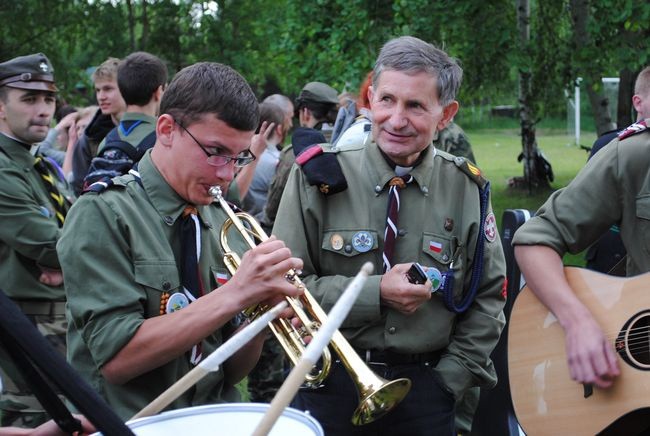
[0,53,58,92]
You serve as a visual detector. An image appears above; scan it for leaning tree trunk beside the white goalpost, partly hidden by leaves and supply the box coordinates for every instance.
[570,0,615,136]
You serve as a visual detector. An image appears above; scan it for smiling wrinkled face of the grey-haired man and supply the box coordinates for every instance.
[368,70,458,166]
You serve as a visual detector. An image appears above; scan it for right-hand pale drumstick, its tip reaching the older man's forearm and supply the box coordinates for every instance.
[253,262,373,436]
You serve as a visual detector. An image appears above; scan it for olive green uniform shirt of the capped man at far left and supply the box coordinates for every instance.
[0,134,67,301]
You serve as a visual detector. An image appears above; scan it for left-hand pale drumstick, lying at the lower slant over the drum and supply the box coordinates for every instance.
[131,301,288,419]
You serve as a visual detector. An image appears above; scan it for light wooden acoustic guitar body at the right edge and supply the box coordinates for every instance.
[508,267,650,436]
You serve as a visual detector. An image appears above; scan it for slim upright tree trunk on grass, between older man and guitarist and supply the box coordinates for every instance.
[514,0,549,193]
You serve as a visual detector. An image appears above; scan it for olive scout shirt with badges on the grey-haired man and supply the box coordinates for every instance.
[273,140,505,398]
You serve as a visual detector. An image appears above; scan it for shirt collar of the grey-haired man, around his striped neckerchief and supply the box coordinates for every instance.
[362,141,436,196]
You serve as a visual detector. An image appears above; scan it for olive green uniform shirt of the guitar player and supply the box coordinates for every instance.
[512,119,650,276]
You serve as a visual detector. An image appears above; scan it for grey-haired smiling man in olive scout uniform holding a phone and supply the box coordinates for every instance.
[274,37,505,435]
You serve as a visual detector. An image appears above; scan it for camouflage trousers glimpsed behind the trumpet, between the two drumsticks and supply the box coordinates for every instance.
[248,333,285,403]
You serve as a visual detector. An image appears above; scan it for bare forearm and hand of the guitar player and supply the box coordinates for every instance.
[515,245,620,388]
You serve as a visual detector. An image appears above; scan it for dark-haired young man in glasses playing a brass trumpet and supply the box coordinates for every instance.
[57,63,302,419]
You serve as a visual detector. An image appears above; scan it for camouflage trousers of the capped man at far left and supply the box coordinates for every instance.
[0,303,67,428]
